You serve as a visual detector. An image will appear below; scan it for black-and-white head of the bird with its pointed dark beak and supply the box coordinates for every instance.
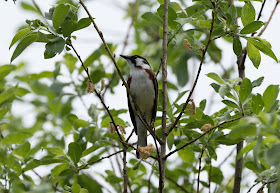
[120,55,151,70]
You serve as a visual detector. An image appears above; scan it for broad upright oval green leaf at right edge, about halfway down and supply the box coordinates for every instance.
[263,85,279,112]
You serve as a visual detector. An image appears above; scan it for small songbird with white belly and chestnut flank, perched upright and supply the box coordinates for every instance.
[120,55,158,158]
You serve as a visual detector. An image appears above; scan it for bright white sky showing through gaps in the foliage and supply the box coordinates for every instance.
[0,0,280,193]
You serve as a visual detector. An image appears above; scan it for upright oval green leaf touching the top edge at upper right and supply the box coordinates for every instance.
[241,1,256,26]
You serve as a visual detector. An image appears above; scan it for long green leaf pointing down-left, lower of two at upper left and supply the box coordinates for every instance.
[11,33,37,62]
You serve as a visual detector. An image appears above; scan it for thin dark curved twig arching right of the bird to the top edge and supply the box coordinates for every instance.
[167,2,216,136]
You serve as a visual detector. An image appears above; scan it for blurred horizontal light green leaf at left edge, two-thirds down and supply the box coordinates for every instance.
[1,131,32,145]
